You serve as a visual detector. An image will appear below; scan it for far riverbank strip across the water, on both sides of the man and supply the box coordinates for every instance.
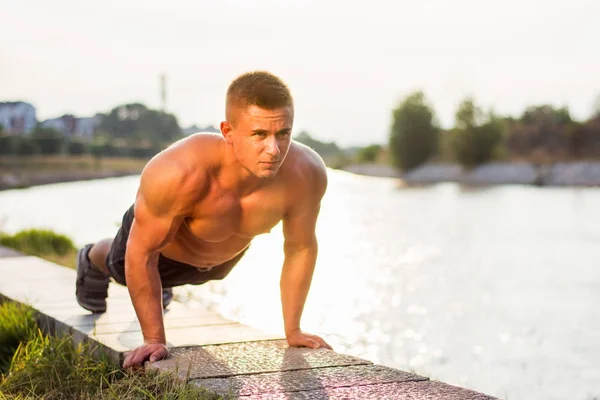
[0,158,600,190]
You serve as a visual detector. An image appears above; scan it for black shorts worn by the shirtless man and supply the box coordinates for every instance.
[106,206,248,288]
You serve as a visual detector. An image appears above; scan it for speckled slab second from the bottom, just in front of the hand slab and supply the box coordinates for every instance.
[192,365,428,396]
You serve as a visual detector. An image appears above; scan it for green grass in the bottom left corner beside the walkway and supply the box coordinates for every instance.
[0,302,223,400]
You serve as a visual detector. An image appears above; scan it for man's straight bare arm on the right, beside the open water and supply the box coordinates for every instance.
[280,155,329,347]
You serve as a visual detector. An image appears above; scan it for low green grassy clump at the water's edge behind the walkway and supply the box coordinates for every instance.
[0,229,76,257]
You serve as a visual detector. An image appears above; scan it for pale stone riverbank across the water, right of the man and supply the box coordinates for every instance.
[343,161,600,186]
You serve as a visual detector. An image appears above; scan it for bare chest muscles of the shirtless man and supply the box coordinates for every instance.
[183,193,285,243]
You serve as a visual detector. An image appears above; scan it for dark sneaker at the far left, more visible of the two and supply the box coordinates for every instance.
[75,244,110,313]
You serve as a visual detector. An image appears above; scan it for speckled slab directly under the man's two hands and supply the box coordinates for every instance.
[149,340,372,379]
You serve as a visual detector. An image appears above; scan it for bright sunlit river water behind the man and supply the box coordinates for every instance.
[0,170,600,400]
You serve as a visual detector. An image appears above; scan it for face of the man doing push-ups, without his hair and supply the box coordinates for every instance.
[226,105,294,178]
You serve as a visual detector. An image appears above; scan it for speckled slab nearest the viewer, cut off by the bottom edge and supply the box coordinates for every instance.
[239,381,495,400]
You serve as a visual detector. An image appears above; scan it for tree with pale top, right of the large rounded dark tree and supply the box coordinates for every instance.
[452,99,504,168]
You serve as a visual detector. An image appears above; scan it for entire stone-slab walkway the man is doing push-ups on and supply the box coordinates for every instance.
[0,247,500,400]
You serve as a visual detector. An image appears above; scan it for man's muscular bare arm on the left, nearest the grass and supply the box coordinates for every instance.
[124,160,203,367]
